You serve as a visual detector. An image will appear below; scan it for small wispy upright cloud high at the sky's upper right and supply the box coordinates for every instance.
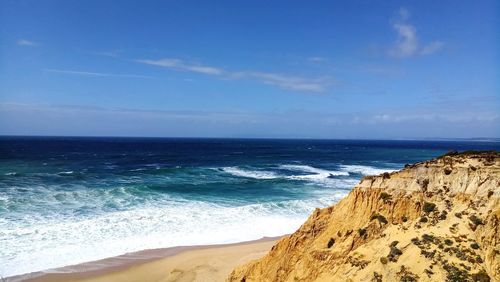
[389,8,444,58]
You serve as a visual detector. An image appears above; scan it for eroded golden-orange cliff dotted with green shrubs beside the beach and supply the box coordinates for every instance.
[228,152,500,282]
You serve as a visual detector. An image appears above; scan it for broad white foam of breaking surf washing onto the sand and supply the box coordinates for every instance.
[0,192,345,277]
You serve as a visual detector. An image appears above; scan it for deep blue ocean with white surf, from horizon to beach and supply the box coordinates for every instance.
[0,137,500,277]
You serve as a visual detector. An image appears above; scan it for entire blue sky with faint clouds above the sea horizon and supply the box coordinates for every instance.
[0,0,500,139]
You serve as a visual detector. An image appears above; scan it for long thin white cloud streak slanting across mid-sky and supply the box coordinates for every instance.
[136,58,333,92]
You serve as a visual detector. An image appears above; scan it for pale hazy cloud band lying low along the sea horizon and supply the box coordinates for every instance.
[0,102,500,138]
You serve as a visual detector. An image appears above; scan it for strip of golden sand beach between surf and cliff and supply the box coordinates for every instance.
[4,234,289,282]
